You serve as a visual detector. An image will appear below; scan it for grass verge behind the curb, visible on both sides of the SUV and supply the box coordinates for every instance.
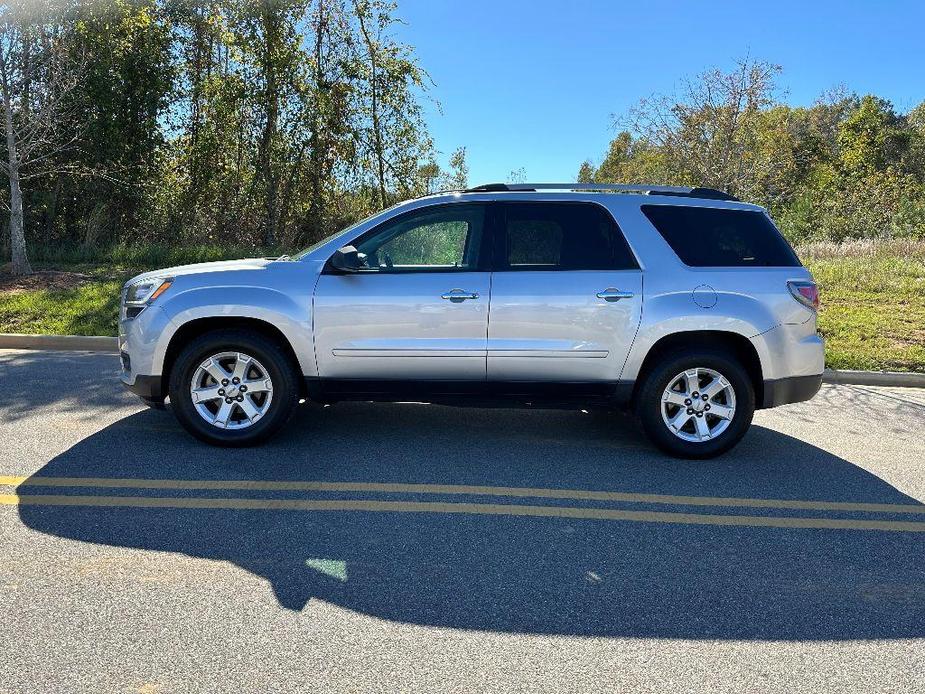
[0,241,925,372]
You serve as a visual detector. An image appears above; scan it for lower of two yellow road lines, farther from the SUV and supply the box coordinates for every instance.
[0,494,925,532]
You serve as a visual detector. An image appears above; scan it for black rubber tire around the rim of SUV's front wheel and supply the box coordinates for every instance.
[169,330,299,447]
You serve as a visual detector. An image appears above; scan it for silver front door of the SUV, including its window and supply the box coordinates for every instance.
[314,203,491,381]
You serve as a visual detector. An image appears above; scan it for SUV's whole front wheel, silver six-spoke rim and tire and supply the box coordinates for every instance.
[170,330,298,446]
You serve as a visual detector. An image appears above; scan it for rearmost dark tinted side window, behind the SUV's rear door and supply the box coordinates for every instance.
[642,205,800,267]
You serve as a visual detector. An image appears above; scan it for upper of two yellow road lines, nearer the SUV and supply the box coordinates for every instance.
[0,475,925,514]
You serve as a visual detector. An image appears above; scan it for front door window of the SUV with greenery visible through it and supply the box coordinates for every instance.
[355,205,485,272]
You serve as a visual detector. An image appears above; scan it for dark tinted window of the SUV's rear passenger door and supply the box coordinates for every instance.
[501,203,637,270]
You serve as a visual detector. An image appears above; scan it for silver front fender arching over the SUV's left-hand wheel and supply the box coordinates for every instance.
[154,287,317,376]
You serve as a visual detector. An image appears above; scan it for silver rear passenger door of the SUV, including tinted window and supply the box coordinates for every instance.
[488,202,642,383]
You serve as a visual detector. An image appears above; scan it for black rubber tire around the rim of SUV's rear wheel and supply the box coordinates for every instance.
[636,348,755,459]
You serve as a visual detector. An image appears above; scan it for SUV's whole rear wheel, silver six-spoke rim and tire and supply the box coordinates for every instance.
[636,350,755,458]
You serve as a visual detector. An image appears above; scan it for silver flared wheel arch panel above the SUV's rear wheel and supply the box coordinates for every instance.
[620,292,778,381]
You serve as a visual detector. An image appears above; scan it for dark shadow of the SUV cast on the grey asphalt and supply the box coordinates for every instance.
[19,403,925,639]
